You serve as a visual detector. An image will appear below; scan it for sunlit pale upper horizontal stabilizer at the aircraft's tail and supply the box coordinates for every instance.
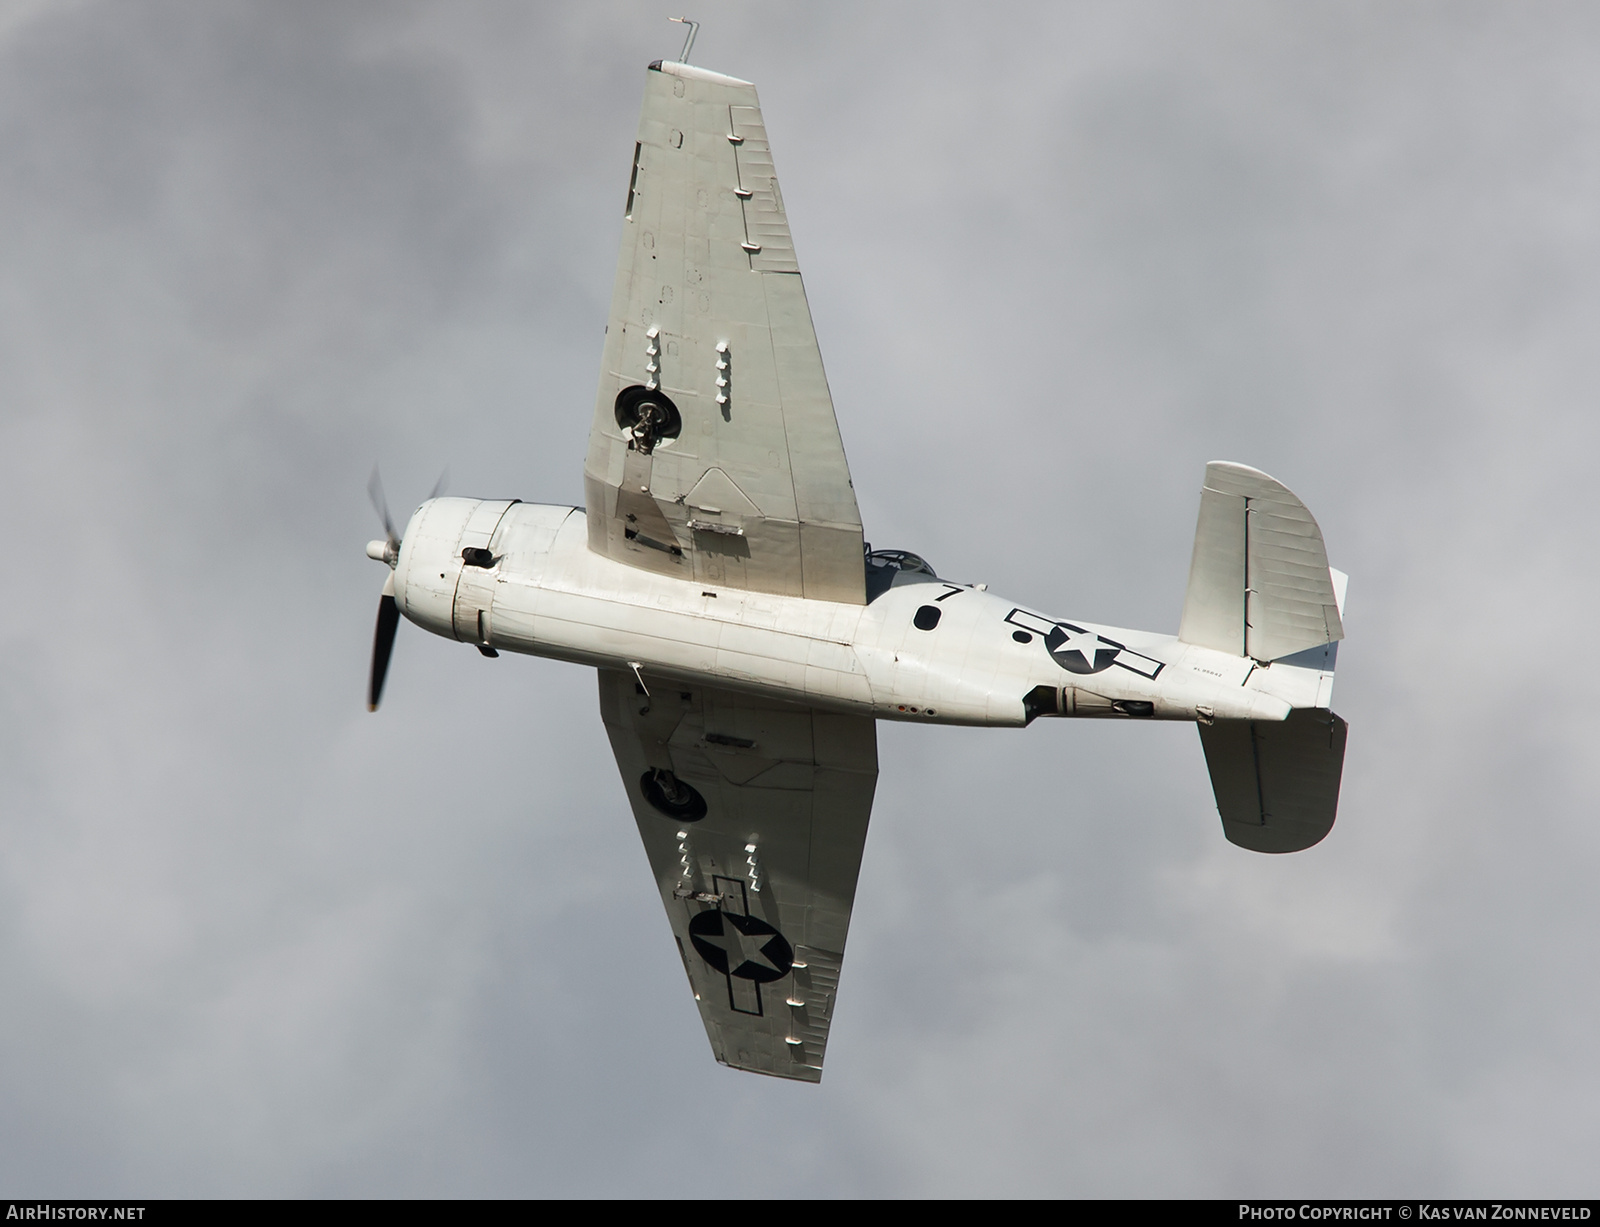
[1178,461,1344,661]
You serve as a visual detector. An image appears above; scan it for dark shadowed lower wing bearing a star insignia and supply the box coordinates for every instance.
[600,669,878,1081]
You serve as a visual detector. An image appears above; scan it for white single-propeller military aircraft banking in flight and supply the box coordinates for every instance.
[366,55,1346,1081]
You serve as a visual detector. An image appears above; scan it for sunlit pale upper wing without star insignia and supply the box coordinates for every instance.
[584,62,866,605]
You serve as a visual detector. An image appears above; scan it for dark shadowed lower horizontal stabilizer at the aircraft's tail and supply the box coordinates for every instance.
[1200,707,1347,853]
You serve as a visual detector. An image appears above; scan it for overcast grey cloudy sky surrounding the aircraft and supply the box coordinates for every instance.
[0,0,1600,1198]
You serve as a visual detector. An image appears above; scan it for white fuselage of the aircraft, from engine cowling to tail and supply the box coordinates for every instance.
[394,498,1333,726]
